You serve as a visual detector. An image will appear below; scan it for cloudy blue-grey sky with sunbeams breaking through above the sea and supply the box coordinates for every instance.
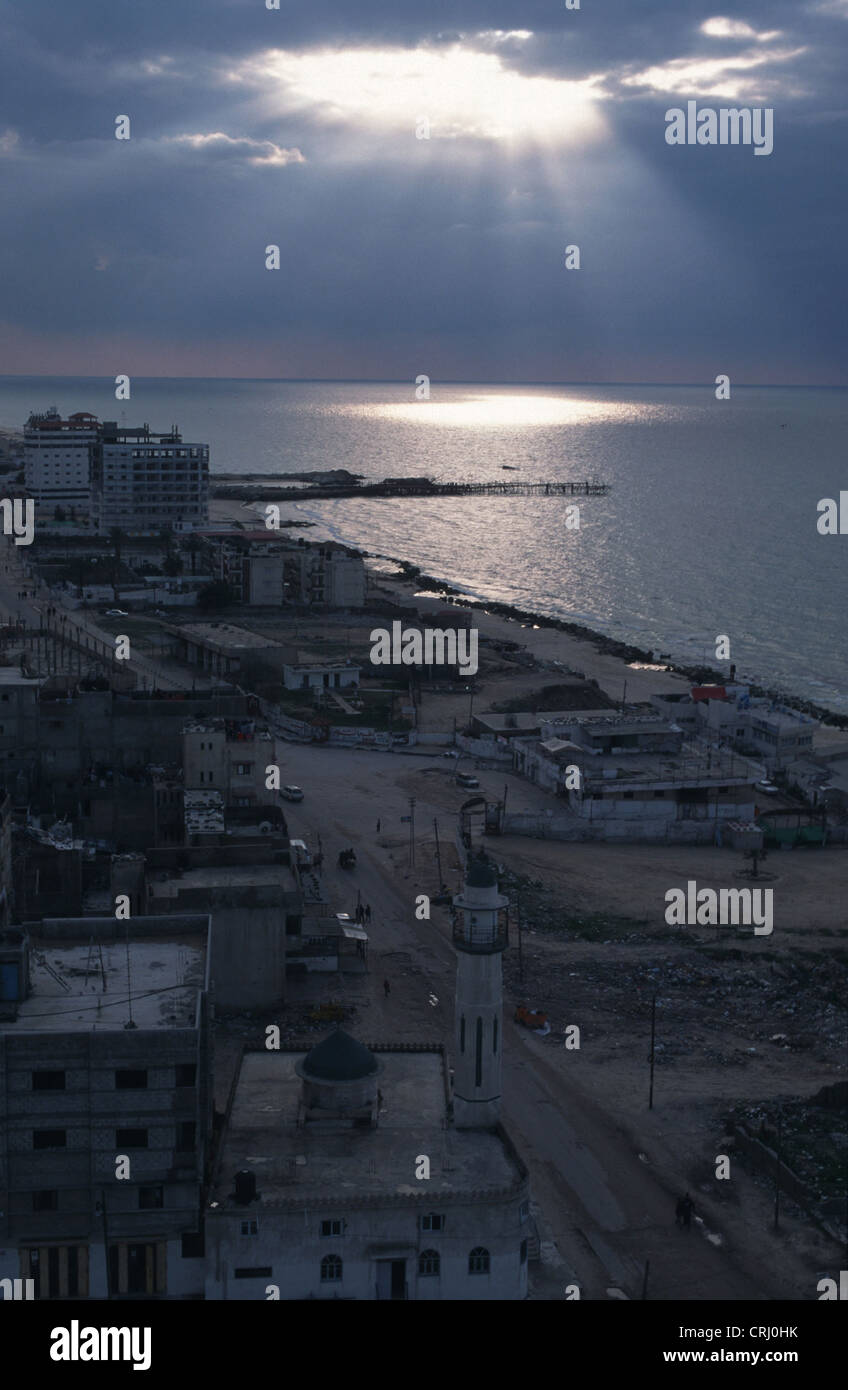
[0,0,848,385]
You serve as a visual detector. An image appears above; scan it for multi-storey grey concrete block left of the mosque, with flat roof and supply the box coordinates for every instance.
[0,915,213,1300]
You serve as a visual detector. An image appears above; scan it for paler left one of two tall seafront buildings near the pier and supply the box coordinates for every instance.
[24,417,100,521]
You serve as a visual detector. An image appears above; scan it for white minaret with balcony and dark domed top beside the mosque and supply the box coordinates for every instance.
[453,860,507,1129]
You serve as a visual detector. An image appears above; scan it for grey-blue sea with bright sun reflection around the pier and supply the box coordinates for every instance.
[0,377,848,713]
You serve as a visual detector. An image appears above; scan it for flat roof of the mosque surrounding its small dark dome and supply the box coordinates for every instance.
[210,1038,523,1213]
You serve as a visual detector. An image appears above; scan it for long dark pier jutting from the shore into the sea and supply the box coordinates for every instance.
[210,475,610,502]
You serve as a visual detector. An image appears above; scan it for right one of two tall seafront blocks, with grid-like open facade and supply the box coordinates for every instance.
[95,420,209,534]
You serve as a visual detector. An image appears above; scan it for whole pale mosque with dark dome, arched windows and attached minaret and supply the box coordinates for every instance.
[206,863,532,1301]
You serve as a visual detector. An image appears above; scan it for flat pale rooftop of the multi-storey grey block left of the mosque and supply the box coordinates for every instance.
[1,915,209,1033]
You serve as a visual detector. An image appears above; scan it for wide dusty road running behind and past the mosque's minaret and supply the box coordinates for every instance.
[269,744,785,1300]
